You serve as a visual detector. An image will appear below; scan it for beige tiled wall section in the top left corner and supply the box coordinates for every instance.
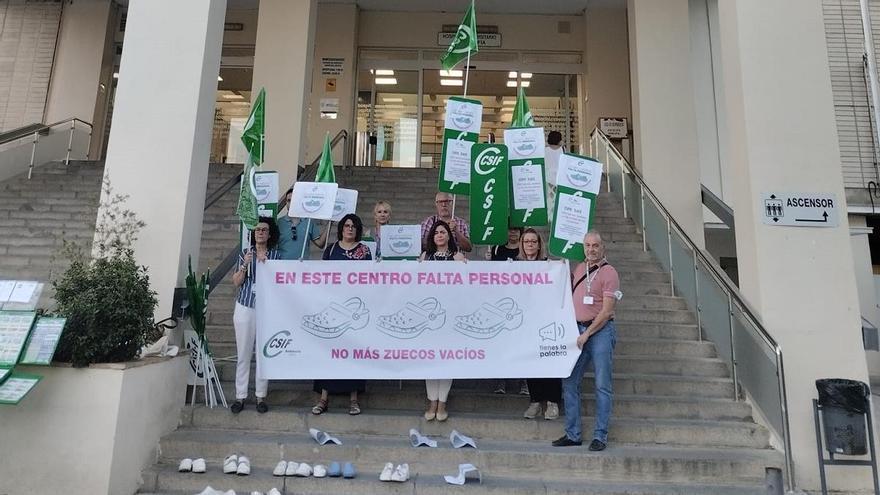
[0,0,61,131]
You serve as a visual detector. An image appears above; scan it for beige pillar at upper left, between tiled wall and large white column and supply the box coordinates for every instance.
[46,0,112,128]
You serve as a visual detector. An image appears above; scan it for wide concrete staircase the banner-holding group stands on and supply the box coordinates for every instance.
[141,166,782,495]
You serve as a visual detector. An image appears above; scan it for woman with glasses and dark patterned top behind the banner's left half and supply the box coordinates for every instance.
[312,213,373,416]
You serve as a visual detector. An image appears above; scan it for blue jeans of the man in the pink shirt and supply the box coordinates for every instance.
[562,321,617,443]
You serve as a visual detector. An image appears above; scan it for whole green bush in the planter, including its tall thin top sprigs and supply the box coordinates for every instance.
[52,179,157,366]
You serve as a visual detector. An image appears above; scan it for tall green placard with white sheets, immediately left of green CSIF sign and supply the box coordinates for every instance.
[437,96,483,196]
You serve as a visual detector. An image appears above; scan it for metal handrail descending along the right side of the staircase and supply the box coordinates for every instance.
[590,128,794,489]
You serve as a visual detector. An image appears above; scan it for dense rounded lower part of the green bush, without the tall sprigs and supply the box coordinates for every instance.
[53,249,157,366]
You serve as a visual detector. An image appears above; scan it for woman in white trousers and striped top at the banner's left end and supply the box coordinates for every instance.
[229,217,279,414]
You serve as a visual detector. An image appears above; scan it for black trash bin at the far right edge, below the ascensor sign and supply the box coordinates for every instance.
[816,378,871,455]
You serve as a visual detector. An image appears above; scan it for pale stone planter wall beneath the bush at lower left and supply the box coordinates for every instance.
[0,356,187,495]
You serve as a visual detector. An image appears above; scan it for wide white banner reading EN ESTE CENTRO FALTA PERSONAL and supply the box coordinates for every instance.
[257,261,578,379]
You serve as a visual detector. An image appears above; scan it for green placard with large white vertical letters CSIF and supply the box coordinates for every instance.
[470,143,510,245]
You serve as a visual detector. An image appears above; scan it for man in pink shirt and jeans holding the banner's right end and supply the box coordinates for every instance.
[553,231,621,451]
